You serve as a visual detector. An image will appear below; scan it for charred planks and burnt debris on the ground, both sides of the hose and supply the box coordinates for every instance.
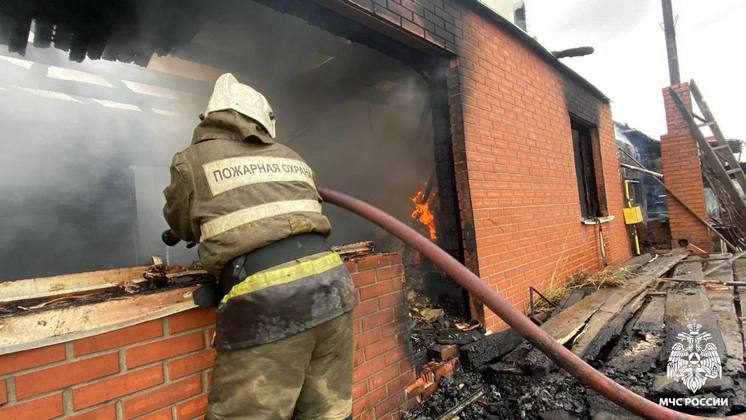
[406,250,746,419]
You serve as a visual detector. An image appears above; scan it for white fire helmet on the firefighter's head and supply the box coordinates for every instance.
[205,73,275,139]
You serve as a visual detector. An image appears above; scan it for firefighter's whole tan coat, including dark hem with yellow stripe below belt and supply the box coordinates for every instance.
[163,106,355,350]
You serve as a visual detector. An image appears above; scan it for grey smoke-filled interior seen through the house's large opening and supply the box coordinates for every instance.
[0,1,437,279]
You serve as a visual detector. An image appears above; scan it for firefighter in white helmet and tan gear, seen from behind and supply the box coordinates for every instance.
[163,73,355,419]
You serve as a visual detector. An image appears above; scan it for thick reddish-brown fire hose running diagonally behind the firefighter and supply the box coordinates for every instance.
[318,187,746,419]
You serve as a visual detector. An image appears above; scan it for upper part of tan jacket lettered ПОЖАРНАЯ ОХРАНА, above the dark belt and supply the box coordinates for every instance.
[163,110,331,276]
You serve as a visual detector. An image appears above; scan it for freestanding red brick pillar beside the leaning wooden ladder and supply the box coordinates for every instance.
[661,83,713,251]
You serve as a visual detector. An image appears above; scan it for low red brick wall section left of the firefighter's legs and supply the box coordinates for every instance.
[0,309,215,419]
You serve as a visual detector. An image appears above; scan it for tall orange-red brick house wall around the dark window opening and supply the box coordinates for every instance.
[451,5,630,330]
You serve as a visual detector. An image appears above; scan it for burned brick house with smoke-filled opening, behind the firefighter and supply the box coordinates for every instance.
[0,0,632,418]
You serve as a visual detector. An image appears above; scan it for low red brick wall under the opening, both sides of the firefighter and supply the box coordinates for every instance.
[0,254,415,420]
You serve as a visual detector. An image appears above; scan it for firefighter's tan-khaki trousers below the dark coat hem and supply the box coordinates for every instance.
[207,312,353,420]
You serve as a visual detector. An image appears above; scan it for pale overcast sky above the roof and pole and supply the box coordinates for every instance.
[526,0,746,151]
